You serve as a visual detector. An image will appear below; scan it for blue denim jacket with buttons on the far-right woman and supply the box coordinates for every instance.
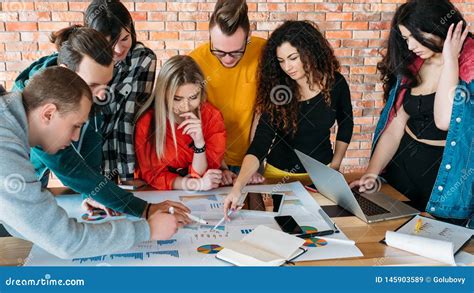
[372,52,474,222]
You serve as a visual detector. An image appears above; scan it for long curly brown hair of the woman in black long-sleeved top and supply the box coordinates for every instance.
[256,21,340,135]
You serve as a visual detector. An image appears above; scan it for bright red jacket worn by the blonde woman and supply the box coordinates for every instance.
[135,103,226,190]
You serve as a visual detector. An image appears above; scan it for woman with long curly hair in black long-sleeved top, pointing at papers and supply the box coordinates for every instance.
[225,21,354,214]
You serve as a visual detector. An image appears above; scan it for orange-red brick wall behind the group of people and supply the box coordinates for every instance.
[0,0,474,171]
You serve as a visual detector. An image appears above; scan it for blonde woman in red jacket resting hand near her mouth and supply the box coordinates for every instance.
[135,56,226,190]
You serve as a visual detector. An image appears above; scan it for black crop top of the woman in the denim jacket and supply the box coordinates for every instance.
[403,91,448,140]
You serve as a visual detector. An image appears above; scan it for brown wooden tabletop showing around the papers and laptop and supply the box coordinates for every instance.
[0,174,474,266]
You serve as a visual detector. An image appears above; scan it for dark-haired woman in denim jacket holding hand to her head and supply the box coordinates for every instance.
[352,0,474,224]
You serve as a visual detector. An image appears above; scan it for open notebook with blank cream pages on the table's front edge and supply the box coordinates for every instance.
[216,225,306,266]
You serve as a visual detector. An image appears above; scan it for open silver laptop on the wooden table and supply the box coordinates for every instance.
[295,150,420,223]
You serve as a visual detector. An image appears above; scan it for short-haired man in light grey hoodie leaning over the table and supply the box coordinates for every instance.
[0,67,190,258]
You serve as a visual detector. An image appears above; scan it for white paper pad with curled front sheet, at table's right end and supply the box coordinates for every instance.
[385,216,474,265]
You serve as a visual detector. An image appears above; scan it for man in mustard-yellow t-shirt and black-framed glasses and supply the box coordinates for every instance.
[190,0,266,184]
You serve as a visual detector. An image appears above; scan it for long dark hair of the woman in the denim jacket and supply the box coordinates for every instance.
[377,0,472,101]
